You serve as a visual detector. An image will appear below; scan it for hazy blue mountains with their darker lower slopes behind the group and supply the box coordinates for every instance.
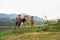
[0,13,44,25]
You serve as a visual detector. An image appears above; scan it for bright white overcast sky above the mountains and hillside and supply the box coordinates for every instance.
[0,0,60,20]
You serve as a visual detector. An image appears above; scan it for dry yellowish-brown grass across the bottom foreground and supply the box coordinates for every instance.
[5,32,60,40]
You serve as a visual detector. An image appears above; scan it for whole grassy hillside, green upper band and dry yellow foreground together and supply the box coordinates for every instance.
[0,25,60,40]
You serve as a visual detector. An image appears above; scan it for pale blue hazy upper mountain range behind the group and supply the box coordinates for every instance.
[0,13,43,21]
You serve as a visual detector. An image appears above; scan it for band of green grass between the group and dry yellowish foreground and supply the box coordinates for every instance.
[0,25,60,37]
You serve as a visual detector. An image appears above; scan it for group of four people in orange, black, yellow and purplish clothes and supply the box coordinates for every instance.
[16,15,34,28]
